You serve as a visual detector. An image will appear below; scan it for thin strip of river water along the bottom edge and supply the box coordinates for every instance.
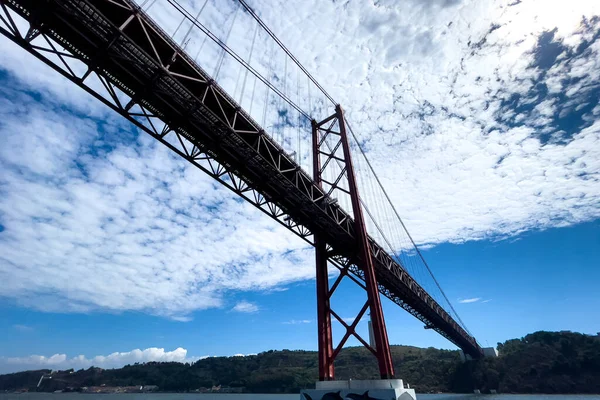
[0,393,600,400]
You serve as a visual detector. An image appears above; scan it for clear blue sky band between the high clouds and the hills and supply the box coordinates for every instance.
[0,221,600,368]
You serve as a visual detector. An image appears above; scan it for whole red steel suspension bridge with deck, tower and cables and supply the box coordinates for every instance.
[0,0,483,380]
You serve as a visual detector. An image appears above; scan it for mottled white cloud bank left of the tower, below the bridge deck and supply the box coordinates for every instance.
[0,76,314,321]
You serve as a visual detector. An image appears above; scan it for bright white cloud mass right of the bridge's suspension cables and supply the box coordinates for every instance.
[216,0,600,247]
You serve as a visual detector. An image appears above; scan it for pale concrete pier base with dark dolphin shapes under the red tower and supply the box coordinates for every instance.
[300,379,417,400]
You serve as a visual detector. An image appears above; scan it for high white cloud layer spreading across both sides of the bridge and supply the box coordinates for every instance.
[0,0,600,320]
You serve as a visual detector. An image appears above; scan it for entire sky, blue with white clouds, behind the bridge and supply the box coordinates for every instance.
[0,0,600,372]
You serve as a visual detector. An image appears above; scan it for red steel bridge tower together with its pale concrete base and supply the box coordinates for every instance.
[308,104,416,400]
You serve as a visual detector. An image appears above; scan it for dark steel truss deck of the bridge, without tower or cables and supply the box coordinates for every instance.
[0,0,482,357]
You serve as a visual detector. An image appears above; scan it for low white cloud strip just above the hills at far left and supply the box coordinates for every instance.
[0,347,201,373]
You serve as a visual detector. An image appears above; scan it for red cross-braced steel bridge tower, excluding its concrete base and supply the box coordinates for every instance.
[312,104,394,381]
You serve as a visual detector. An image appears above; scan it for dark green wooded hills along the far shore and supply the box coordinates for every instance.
[0,332,600,393]
